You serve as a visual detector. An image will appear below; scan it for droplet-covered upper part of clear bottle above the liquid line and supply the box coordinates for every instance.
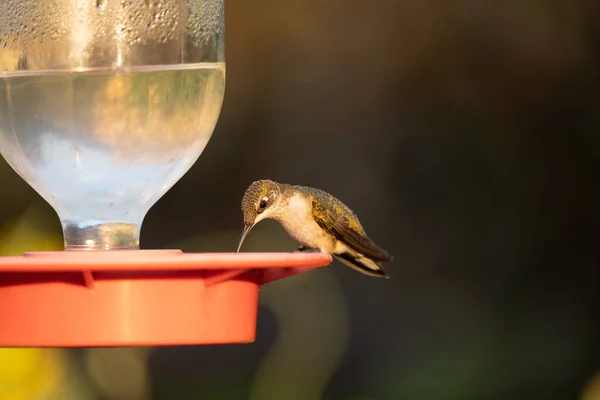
[0,0,225,72]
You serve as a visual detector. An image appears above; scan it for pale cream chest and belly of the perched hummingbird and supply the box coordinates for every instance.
[277,195,334,252]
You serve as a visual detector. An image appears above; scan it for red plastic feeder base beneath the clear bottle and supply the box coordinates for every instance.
[0,250,331,347]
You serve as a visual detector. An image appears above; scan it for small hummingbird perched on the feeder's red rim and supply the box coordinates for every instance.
[236,179,393,278]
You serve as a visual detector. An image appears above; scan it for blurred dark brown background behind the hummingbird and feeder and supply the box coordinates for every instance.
[0,0,600,400]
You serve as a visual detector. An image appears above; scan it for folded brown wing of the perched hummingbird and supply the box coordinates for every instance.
[312,200,392,261]
